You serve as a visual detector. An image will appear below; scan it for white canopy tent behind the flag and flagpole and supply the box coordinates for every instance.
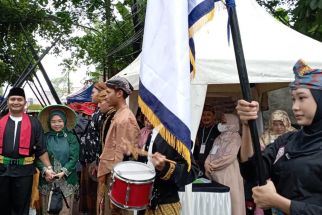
[117,0,322,139]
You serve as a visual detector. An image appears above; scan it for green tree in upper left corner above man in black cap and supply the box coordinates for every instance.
[0,0,72,85]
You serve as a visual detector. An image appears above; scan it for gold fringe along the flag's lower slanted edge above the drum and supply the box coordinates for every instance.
[138,96,191,172]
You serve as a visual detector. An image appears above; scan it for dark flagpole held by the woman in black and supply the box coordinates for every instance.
[226,0,271,215]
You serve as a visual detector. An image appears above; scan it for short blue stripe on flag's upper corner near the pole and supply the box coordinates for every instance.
[189,0,216,28]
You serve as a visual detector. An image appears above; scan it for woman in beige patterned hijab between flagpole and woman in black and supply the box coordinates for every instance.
[260,110,296,150]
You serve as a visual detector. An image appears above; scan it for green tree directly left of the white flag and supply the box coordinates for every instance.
[60,0,146,78]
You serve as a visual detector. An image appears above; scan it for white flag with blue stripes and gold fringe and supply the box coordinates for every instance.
[138,0,214,170]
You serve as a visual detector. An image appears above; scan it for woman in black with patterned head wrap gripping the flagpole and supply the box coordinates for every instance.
[236,60,322,215]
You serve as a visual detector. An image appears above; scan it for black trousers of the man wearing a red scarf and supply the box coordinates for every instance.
[0,175,33,215]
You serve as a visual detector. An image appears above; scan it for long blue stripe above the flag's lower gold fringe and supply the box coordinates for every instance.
[139,81,191,149]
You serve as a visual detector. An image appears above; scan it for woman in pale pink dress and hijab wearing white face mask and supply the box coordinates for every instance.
[205,114,246,215]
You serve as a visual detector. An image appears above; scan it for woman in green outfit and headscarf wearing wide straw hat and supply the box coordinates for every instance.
[37,105,79,215]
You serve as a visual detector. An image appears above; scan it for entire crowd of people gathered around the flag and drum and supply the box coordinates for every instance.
[0,61,322,215]
